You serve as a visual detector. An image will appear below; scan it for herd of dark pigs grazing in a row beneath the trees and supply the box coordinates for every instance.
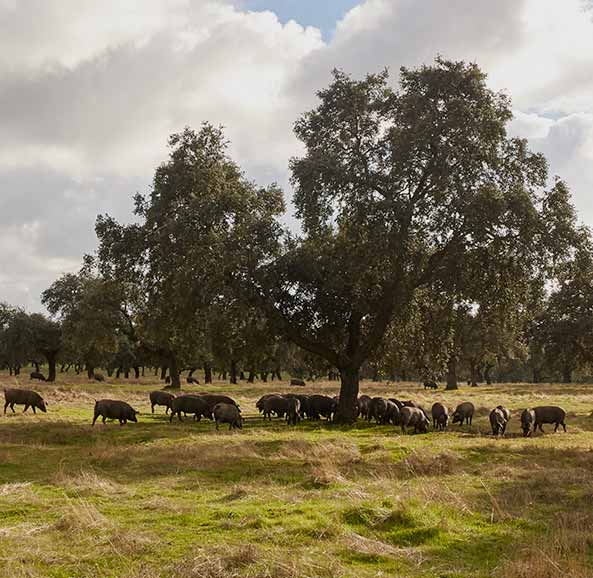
[4,388,566,436]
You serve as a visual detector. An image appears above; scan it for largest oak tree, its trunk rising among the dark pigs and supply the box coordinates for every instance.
[252,59,570,422]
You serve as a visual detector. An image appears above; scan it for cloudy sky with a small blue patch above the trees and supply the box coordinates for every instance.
[0,0,593,311]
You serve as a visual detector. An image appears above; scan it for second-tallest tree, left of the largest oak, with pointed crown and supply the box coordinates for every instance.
[96,124,283,387]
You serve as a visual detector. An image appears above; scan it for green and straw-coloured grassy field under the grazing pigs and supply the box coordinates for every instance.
[0,374,593,578]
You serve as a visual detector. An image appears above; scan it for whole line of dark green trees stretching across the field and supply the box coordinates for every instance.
[0,58,593,422]
